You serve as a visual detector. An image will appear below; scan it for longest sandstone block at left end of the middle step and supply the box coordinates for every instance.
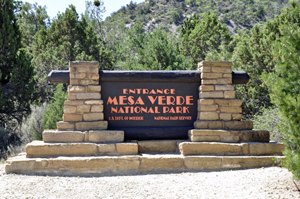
[26,141,98,157]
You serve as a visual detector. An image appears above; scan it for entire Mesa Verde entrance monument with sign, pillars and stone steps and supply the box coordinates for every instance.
[5,62,284,176]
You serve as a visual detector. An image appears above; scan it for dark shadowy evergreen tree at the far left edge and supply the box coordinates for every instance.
[0,0,36,127]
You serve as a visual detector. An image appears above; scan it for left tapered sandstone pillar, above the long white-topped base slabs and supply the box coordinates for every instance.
[57,62,107,130]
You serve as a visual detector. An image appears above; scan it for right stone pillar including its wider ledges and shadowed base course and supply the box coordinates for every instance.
[189,61,269,142]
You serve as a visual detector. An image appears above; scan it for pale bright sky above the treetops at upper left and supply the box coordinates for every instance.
[22,0,145,19]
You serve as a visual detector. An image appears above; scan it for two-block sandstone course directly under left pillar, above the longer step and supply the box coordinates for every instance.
[43,130,124,143]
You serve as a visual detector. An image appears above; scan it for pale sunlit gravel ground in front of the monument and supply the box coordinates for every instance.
[0,164,300,199]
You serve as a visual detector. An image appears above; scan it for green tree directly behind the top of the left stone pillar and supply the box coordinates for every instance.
[32,5,113,100]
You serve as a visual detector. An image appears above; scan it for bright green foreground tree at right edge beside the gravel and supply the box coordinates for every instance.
[263,24,300,179]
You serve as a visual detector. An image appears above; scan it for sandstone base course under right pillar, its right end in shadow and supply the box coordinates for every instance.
[188,129,270,142]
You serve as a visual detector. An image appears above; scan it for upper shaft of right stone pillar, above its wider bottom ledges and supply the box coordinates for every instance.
[197,62,242,120]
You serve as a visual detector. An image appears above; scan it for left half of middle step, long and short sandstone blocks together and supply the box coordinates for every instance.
[26,141,138,158]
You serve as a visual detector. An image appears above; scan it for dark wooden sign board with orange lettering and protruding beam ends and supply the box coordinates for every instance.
[48,70,249,140]
